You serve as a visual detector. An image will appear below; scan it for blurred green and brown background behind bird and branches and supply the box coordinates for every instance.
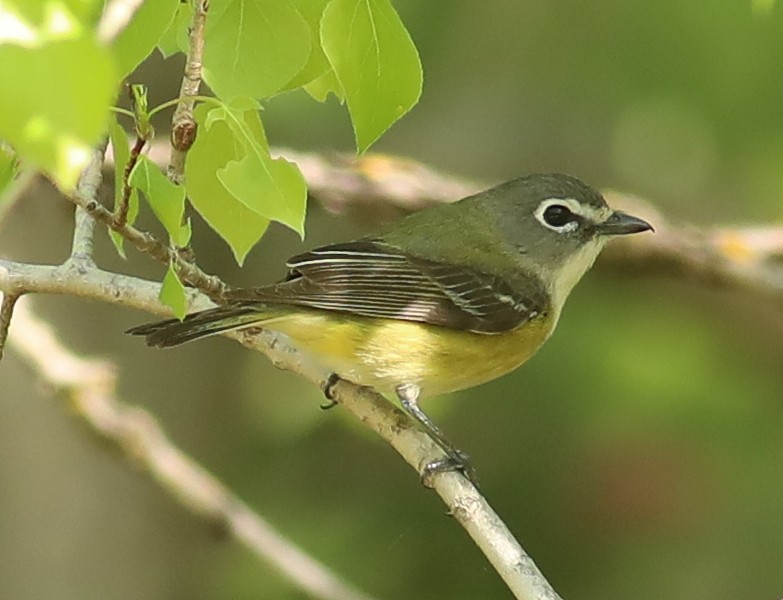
[0,0,783,600]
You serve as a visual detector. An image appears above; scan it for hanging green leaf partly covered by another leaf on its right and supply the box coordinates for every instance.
[185,105,269,265]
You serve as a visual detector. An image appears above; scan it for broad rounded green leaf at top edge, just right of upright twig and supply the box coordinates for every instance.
[204,0,310,100]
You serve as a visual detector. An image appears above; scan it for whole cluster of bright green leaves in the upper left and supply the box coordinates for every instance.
[0,0,422,313]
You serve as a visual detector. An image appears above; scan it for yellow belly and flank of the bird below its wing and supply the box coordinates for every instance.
[260,308,554,396]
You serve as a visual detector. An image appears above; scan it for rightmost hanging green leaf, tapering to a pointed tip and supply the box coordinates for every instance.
[321,0,422,152]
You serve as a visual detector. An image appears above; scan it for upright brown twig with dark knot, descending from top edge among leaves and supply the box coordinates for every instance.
[168,0,209,183]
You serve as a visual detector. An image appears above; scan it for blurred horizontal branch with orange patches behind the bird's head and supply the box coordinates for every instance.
[150,145,783,301]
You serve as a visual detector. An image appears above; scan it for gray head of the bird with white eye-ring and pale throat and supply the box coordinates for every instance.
[485,174,652,306]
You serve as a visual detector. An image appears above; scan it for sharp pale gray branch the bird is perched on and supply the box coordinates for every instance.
[0,259,558,600]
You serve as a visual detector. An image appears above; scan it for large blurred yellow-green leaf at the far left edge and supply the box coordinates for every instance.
[0,15,116,192]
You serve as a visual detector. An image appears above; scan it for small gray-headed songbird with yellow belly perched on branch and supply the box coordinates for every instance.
[128,174,652,473]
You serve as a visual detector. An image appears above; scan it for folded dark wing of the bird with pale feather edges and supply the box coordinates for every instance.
[228,240,547,333]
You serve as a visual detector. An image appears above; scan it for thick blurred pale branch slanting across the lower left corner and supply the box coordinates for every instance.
[6,303,370,600]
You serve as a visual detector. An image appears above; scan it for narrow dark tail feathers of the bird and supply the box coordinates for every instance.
[125,304,269,348]
